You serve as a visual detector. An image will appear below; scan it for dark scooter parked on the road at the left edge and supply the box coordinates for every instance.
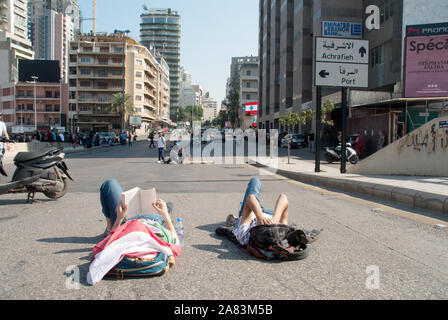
[0,138,73,203]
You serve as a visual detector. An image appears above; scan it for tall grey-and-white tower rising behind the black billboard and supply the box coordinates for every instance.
[28,0,80,82]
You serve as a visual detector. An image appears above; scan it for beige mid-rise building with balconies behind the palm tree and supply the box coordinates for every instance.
[69,34,170,134]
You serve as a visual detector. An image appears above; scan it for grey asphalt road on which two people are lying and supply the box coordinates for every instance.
[0,143,448,300]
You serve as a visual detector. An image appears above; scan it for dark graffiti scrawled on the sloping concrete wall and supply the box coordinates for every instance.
[398,121,448,155]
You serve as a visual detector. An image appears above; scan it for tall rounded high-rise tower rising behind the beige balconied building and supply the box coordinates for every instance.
[140,9,181,117]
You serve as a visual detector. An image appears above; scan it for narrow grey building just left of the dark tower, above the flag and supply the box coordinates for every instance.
[239,60,259,130]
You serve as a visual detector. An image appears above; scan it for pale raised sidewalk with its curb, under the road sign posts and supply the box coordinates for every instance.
[252,149,448,216]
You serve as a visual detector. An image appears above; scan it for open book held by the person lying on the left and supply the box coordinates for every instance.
[121,188,157,219]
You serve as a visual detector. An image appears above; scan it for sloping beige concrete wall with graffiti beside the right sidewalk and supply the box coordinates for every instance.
[348,117,448,177]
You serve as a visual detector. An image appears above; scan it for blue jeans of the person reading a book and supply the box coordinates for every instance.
[100,179,164,225]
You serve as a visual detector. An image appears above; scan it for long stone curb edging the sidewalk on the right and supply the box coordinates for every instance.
[250,162,448,217]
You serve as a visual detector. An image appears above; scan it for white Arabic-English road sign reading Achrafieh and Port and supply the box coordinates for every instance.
[314,37,369,88]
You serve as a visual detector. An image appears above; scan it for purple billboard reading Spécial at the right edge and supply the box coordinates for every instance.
[405,29,448,98]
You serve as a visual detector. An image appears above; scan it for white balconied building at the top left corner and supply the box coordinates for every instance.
[0,0,34,86]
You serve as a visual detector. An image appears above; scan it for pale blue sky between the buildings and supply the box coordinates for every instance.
[78,0,259,105]
